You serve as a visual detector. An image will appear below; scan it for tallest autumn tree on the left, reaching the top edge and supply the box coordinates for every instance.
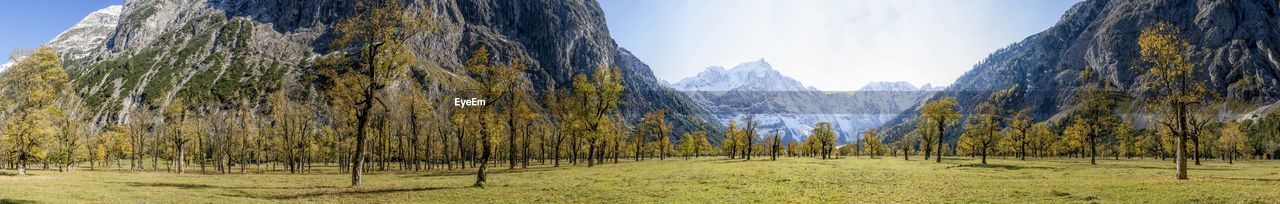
[321,0,430,186]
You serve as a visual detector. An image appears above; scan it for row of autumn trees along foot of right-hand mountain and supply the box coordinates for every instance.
[897,23,1280,180]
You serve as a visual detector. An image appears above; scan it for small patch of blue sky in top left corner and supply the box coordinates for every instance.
[0,0,124,59]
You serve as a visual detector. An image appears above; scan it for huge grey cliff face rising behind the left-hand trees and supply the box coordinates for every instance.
[62,0,718,137]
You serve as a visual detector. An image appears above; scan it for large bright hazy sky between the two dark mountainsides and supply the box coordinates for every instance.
[600,0,1079,90]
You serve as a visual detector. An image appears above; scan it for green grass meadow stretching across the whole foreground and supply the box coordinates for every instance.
[0,158,1280,203]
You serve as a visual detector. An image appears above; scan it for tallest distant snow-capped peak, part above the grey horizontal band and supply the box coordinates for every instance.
[672,59,817,91]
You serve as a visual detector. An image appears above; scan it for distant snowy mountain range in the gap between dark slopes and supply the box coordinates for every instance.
[669,59,925,144]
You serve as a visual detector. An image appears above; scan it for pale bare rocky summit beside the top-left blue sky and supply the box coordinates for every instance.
[49,5,124,60]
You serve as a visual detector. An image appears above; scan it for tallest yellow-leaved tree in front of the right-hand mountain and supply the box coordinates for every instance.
[1138,22,1208,180]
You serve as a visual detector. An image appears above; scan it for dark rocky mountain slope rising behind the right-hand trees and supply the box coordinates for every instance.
[884,0,1280,140]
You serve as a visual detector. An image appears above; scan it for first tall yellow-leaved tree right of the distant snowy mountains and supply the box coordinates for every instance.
[915,98,960,163]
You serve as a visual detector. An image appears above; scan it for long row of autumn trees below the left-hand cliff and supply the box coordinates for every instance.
[0,1,645,186]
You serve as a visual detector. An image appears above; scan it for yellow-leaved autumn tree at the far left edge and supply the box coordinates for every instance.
[0,46,67,176]
